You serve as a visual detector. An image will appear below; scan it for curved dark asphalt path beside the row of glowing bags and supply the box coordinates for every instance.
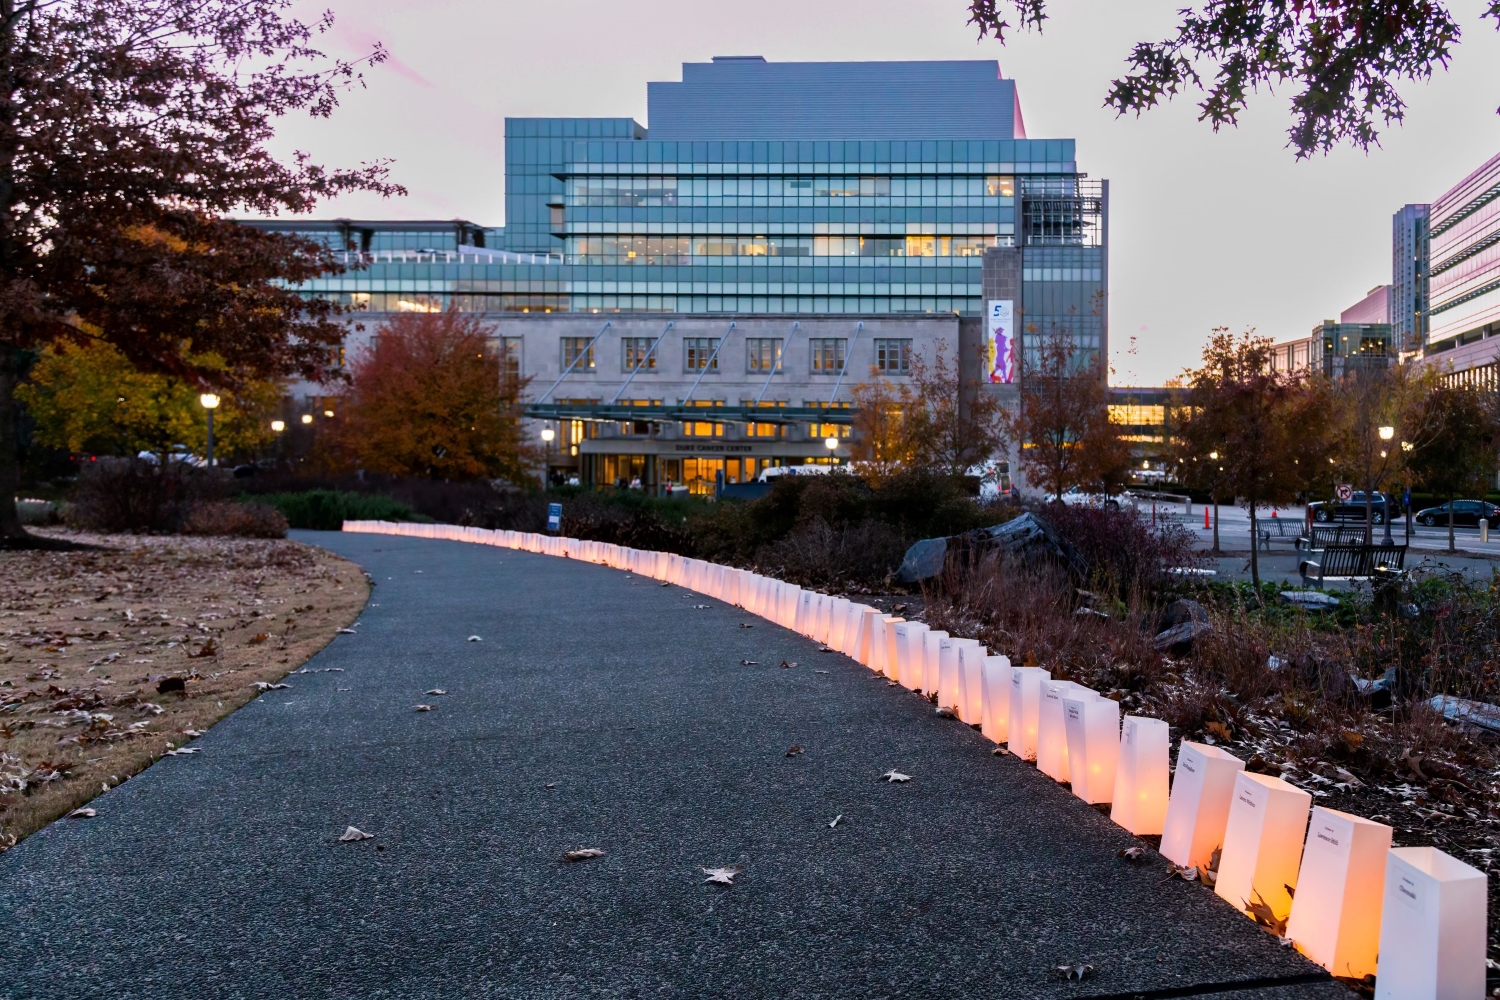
[0,532,1349,1000]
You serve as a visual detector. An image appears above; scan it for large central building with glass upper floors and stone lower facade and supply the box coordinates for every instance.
[254,57,1109,488]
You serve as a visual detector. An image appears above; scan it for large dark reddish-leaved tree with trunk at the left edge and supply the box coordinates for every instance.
[0,0,401,547]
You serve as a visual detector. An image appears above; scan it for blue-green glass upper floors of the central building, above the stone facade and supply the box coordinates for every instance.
[263,57,1103,322]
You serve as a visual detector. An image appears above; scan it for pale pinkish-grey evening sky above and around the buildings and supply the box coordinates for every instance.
[264,0,1500,384]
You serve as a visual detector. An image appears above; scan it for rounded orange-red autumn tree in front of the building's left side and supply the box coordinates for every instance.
[339,310,537,484]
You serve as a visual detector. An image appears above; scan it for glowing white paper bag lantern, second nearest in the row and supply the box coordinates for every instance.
[1290,803,1391,979]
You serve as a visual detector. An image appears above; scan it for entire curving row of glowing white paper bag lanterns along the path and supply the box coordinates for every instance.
[344,522,1488,1000]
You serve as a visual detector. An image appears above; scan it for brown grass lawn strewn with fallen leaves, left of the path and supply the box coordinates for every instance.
[0,531,369,852]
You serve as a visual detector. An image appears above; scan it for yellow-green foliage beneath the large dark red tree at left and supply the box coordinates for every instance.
[17,340,281,460]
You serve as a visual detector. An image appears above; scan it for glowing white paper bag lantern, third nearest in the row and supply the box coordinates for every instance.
[1214,771,1313,919]
